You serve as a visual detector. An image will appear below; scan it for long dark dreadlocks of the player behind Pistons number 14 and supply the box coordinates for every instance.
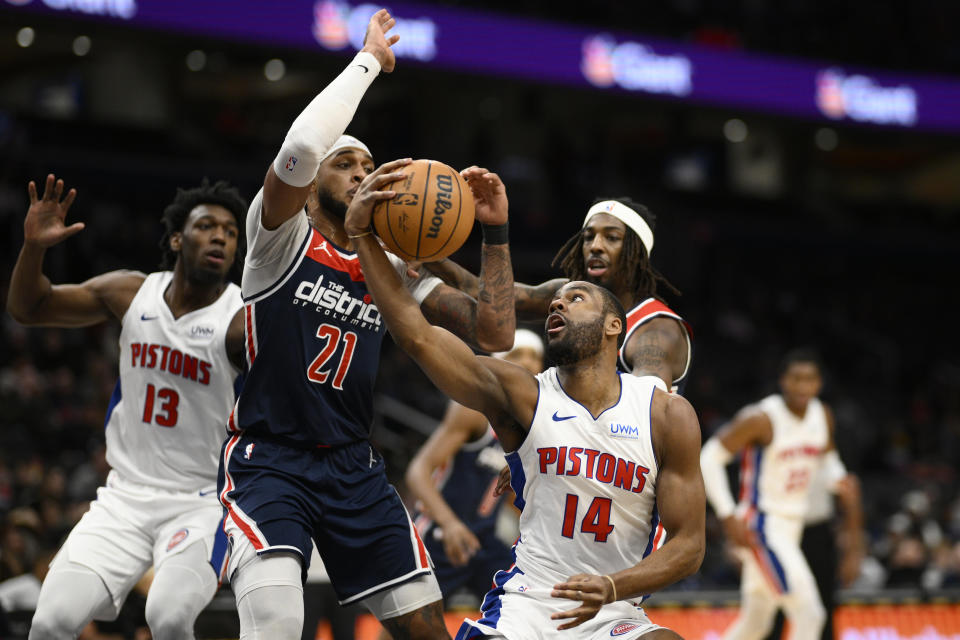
[551,196,681,302]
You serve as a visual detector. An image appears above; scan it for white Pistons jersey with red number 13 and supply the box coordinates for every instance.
[105,271,243,492]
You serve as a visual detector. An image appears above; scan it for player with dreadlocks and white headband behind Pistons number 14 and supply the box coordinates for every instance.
[427,198,692,393]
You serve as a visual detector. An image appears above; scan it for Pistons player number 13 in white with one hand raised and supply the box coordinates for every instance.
[7,175,246,640]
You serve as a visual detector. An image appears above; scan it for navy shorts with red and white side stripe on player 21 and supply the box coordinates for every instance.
[218,433,431,604]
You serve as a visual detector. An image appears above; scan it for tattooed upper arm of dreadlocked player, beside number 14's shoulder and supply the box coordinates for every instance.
[624,318,689,389]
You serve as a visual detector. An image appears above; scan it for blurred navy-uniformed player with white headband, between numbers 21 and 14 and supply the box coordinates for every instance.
[406,329,543,598]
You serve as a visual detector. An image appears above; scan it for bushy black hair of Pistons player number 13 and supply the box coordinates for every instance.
[160,178,247,276]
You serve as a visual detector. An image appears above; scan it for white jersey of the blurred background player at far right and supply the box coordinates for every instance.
[740,394,830,518]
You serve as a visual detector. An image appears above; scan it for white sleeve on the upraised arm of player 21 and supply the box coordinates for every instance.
[273,51,380,187]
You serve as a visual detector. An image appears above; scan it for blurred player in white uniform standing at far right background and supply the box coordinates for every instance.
[700,350,860,640]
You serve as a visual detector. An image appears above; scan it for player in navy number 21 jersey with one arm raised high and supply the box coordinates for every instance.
[220,10,515,640]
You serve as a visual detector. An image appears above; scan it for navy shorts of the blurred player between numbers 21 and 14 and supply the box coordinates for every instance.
[424,525,513,600]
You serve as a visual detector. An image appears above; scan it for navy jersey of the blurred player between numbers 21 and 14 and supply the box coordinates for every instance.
[416,426,506,540]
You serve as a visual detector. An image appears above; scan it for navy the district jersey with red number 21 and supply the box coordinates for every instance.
[228,193,439,447]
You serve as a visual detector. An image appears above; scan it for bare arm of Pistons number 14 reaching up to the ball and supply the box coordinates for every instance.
[344,160,537,449]
